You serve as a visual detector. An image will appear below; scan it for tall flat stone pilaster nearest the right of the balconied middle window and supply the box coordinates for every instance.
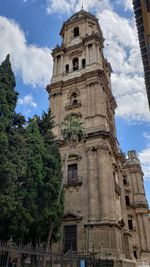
[87,148,96,221]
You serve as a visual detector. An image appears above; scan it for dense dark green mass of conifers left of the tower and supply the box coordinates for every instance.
[0,56,63,245]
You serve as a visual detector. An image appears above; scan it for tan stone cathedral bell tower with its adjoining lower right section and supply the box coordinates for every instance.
[47,10,150,266]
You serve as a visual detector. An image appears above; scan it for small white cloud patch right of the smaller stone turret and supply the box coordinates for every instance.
[138,147,150,180]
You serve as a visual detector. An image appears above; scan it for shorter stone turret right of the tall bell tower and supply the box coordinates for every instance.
[123,151,150,262]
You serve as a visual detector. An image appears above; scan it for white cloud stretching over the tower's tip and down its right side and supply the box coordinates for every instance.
[48,0,150,121]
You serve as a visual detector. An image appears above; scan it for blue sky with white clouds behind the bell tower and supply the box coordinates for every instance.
[0,0,150,205]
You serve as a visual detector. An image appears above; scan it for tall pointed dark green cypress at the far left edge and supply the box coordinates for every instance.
[0,55,21,240]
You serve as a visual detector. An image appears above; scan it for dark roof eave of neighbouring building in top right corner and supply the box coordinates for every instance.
[133,0,150,106]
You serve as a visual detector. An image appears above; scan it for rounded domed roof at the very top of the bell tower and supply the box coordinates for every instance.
[60,9,98,35]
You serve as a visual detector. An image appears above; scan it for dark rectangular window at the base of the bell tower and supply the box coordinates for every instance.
[64,225,77,253]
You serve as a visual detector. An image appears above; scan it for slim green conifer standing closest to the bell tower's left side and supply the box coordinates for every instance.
[37,110,63,266]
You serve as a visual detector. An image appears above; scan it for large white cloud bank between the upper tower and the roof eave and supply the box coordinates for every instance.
[97,9,150,121]
